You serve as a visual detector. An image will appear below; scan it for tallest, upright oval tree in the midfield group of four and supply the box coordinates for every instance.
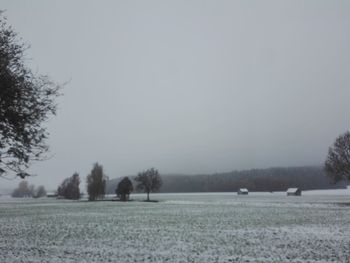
[86,163,107,201]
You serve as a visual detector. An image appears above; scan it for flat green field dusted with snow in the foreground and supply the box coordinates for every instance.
[0,193,350,263]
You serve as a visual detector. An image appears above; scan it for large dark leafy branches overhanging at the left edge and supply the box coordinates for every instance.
[0,12,59,178]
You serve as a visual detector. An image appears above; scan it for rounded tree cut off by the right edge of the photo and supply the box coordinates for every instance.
[325,131,350,182]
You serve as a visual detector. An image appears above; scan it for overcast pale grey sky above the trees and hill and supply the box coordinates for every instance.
[0,0,350,189]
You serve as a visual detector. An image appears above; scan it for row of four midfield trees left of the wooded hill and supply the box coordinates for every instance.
[57,163,162,201]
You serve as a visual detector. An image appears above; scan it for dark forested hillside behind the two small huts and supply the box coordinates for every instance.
[106,166,346,194]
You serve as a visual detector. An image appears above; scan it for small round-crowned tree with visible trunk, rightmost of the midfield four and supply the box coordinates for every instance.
[135,168,162,201]
